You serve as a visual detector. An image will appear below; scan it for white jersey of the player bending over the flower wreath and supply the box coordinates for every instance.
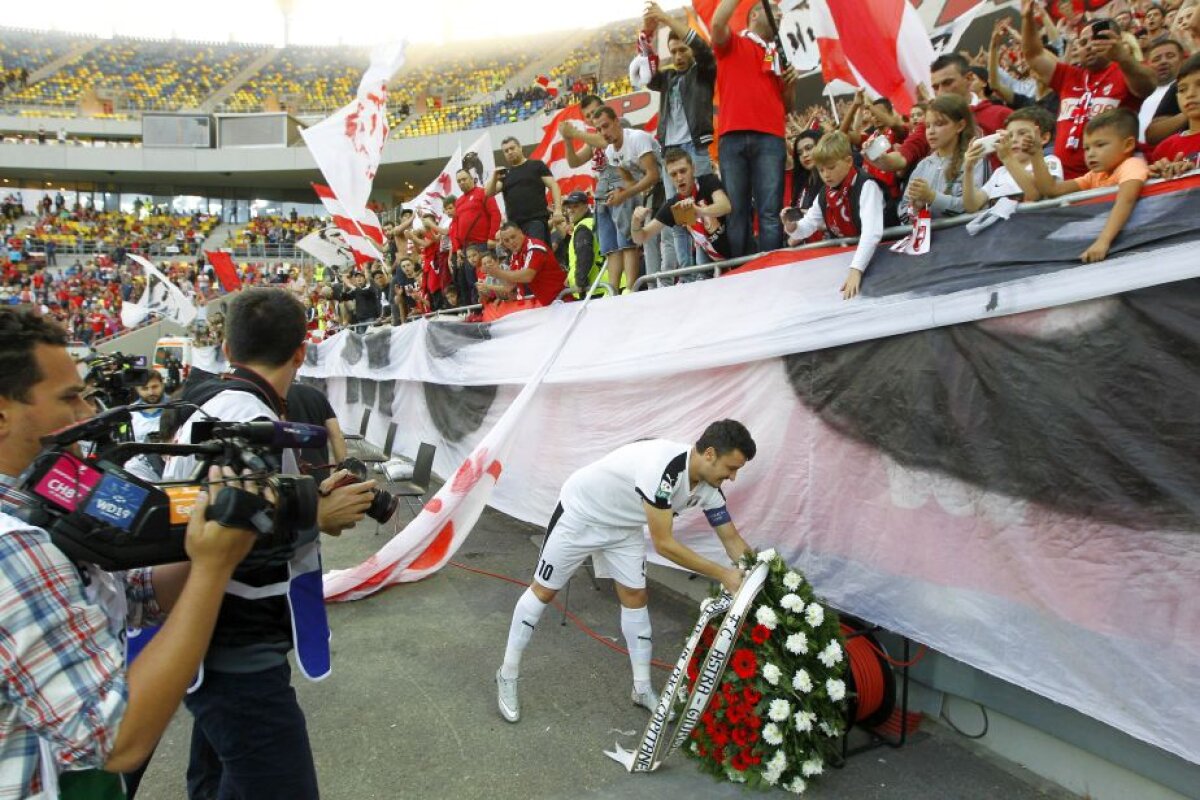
[559,439,725,529]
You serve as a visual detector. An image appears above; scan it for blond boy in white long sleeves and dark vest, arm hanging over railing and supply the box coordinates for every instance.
[780,131,884,300]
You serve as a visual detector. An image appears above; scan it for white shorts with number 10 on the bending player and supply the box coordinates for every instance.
[533,506,646,591]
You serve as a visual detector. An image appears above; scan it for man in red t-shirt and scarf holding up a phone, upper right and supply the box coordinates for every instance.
[1021,0,1156,180]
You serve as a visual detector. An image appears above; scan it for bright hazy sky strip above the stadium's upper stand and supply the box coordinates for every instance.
[2,0,684,44]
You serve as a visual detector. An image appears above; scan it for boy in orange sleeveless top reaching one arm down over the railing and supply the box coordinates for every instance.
[1033,108,1150,264]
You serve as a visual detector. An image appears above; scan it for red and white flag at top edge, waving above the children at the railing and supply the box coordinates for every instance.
[811,0,934,114]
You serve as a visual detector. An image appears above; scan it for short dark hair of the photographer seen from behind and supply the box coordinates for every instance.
[226,287,307,367]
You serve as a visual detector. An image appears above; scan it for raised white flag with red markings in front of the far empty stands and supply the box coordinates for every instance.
[300,43,404,210]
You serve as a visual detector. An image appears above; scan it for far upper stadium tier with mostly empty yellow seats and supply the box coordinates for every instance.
[0,20,637,137]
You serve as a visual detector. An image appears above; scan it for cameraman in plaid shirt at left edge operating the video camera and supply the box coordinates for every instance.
[0,309,254,798]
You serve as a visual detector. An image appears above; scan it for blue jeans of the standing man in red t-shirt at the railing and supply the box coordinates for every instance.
[718,131,787,258]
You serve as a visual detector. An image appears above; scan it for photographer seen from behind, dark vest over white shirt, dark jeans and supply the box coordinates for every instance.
[166,289,374,800]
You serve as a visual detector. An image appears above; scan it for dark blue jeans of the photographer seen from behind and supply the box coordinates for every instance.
[184,663,318,800]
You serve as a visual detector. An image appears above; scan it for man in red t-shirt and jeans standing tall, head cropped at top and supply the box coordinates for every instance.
[712,0,796,257]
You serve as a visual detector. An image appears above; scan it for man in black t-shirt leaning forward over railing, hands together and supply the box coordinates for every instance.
[631,148,733,264]
